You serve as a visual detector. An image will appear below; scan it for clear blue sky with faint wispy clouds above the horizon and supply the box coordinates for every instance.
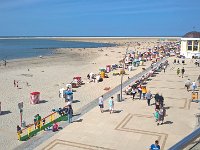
[0,0,200,36]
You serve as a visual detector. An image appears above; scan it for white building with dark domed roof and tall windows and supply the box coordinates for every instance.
[180,32,200,58]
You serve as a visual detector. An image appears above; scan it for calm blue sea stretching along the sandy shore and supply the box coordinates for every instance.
[0,37,115,61]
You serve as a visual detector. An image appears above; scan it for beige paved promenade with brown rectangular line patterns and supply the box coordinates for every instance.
[35,58,200,150]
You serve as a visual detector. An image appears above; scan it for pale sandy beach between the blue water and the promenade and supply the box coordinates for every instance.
[0,38,180,149]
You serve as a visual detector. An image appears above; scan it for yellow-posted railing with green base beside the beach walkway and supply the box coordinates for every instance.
[17,112,67,141]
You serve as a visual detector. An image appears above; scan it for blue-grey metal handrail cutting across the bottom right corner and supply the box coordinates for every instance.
[169,127,200,150]
